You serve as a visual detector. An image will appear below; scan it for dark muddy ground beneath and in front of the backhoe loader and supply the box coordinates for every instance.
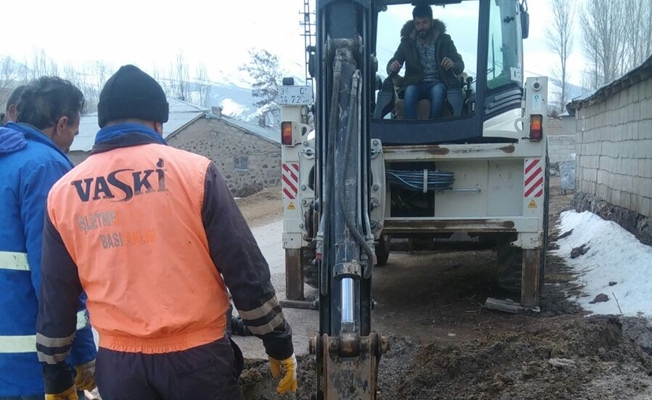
[239,177,652,400]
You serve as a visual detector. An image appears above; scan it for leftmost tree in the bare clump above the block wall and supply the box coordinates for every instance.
[581,0,628,89]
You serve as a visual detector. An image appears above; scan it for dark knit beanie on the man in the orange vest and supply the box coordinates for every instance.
[97,65,169,128]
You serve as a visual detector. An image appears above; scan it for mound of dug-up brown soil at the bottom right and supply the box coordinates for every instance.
[385,317,652,400]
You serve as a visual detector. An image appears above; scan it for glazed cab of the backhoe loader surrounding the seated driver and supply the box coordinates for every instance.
[371,0,529,145]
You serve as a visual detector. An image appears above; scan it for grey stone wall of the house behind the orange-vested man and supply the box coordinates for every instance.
[168,118,281,196]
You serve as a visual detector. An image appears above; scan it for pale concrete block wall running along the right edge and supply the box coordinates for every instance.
[576,78,652,217]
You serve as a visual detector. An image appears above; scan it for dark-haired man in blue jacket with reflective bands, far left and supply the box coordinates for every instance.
[0,77,96,400]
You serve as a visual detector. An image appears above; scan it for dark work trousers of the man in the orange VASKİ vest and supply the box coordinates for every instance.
[95,337,244,400]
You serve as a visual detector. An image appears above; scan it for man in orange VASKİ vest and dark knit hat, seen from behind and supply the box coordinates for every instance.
[37,65,297,400]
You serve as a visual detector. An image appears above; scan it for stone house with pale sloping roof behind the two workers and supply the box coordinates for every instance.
[69,98,281,196]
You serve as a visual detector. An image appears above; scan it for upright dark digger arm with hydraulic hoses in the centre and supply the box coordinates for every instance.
[310,0,389,400]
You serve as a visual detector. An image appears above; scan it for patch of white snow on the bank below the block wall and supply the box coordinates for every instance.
[551,211,652,317]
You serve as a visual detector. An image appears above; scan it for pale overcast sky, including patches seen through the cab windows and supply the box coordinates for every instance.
[0,0,582,88]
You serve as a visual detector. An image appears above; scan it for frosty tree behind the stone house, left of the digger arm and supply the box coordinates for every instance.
[240,49,282,126]
